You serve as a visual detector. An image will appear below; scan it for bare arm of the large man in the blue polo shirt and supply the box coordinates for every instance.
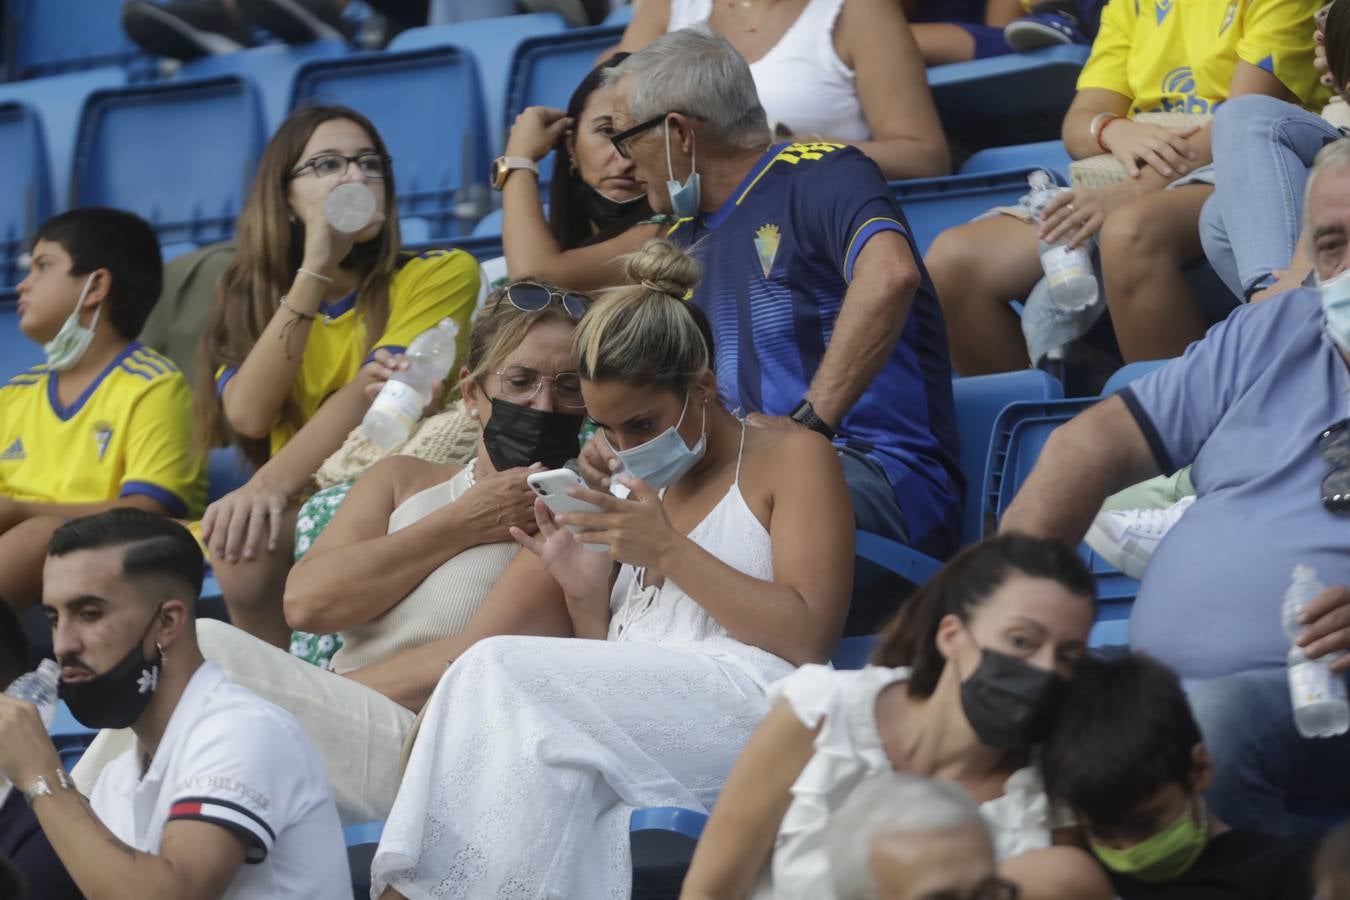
[999,395,1158,544]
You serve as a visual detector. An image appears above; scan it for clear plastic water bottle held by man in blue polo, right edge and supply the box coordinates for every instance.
[1280,565,1350,738]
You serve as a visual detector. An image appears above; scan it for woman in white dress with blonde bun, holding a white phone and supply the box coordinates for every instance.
[373,242,852,897]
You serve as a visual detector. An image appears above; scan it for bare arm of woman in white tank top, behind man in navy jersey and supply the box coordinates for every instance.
[826,0,952,181]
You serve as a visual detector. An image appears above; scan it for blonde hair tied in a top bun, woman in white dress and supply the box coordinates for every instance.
[572,239,713,393]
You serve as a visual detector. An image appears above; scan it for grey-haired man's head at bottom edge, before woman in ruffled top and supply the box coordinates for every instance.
[826,772,1015,900]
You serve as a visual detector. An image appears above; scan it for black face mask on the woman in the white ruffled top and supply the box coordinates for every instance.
[961,648,1064,750]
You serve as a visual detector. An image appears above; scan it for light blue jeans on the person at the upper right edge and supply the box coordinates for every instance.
[1200,94,1341,301]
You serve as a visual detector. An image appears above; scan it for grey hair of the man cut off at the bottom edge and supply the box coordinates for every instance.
[825,772,992,900]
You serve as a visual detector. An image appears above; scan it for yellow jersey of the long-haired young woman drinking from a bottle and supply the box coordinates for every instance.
[216,250,478,455]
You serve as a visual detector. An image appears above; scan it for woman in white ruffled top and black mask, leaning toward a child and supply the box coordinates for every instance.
[680,534,1114,900]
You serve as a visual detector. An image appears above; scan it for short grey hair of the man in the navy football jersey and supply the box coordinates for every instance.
[602,26,771,150]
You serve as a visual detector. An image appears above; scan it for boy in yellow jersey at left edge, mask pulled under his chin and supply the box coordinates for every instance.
[0,208,205,610]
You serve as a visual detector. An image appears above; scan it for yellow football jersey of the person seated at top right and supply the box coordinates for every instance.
[1079,0,1330,116]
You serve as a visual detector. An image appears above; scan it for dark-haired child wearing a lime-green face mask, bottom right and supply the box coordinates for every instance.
[1041,654,1312,900]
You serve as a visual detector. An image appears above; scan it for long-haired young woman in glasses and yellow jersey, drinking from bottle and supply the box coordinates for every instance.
[196,107,478,646]
